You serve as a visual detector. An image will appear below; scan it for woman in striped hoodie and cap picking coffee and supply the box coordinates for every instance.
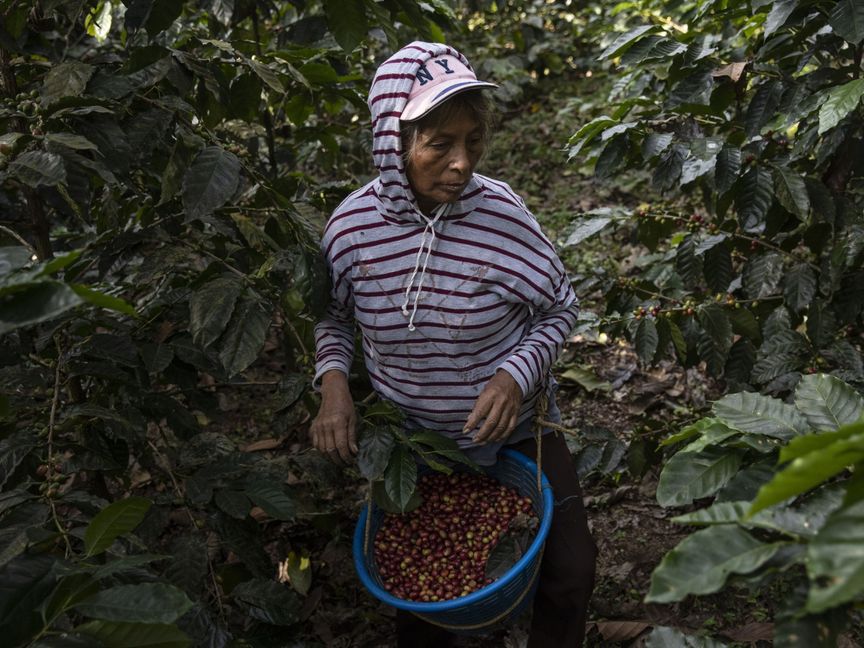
[310,41,595,648]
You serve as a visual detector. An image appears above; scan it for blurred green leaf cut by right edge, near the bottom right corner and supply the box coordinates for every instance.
[806,501,864,613]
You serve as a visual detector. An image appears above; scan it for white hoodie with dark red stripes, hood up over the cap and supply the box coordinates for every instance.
[315,41,577,463]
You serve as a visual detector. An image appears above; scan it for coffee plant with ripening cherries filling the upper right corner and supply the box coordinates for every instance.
[568,0,864,393]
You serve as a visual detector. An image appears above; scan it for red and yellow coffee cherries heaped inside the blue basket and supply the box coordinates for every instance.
[374,473,536,602]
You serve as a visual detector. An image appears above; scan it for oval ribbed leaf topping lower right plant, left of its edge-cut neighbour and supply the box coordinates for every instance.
[713,392,809,441]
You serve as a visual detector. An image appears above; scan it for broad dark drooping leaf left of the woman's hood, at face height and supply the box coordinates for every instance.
[183,146,240,220]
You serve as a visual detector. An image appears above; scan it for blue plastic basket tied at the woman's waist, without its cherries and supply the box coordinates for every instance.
[354,449,553,634]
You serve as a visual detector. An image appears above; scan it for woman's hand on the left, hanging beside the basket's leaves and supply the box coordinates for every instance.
[309,370,357,464]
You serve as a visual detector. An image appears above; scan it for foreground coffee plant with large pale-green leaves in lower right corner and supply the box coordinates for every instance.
[646,374,864,648]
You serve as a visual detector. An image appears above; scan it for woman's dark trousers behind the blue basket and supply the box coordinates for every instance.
[396,433,597,648]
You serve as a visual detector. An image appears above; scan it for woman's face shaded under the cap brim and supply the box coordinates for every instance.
[407,110,484,213]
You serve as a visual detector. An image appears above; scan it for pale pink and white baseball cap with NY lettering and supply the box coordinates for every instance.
[400,55,498,121]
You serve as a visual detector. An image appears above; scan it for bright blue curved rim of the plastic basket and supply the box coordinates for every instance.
[353,448,554,616]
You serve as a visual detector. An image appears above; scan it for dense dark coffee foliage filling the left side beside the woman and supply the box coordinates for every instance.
[0,0,452,647]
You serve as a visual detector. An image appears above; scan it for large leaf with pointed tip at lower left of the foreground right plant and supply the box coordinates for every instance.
[645,526,785,603]
